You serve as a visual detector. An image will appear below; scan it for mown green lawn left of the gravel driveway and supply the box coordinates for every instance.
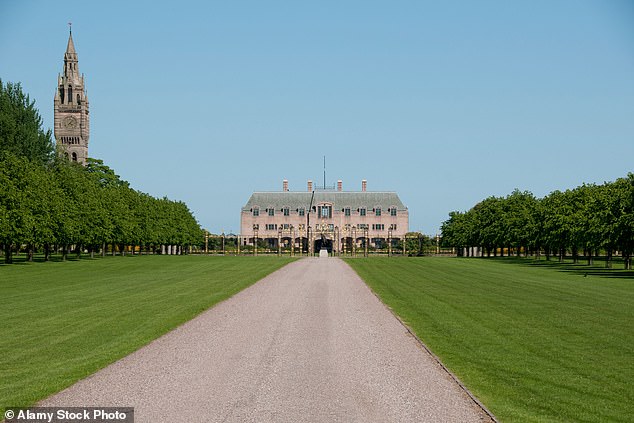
[0,256,291,409]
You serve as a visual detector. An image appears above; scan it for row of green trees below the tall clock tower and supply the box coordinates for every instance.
[0,80,203,263]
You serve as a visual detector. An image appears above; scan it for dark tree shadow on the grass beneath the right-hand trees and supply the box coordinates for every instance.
[478,257,634,279]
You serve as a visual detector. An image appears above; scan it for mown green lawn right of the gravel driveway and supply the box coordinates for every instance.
[347,258,634,422]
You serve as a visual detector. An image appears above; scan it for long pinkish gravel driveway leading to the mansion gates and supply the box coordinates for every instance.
[40,258,490,423]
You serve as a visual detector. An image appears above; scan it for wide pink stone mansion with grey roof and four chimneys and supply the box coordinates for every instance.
[240,180,409,252]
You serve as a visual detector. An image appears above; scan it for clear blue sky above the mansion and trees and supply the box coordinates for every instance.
[0,0,634,234]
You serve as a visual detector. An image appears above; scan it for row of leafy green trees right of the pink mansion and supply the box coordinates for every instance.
[442,173,634,269]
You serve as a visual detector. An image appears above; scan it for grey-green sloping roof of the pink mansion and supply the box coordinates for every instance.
[242,191,407,212]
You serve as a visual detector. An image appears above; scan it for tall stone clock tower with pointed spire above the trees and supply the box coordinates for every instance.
[53,26,90,165]
